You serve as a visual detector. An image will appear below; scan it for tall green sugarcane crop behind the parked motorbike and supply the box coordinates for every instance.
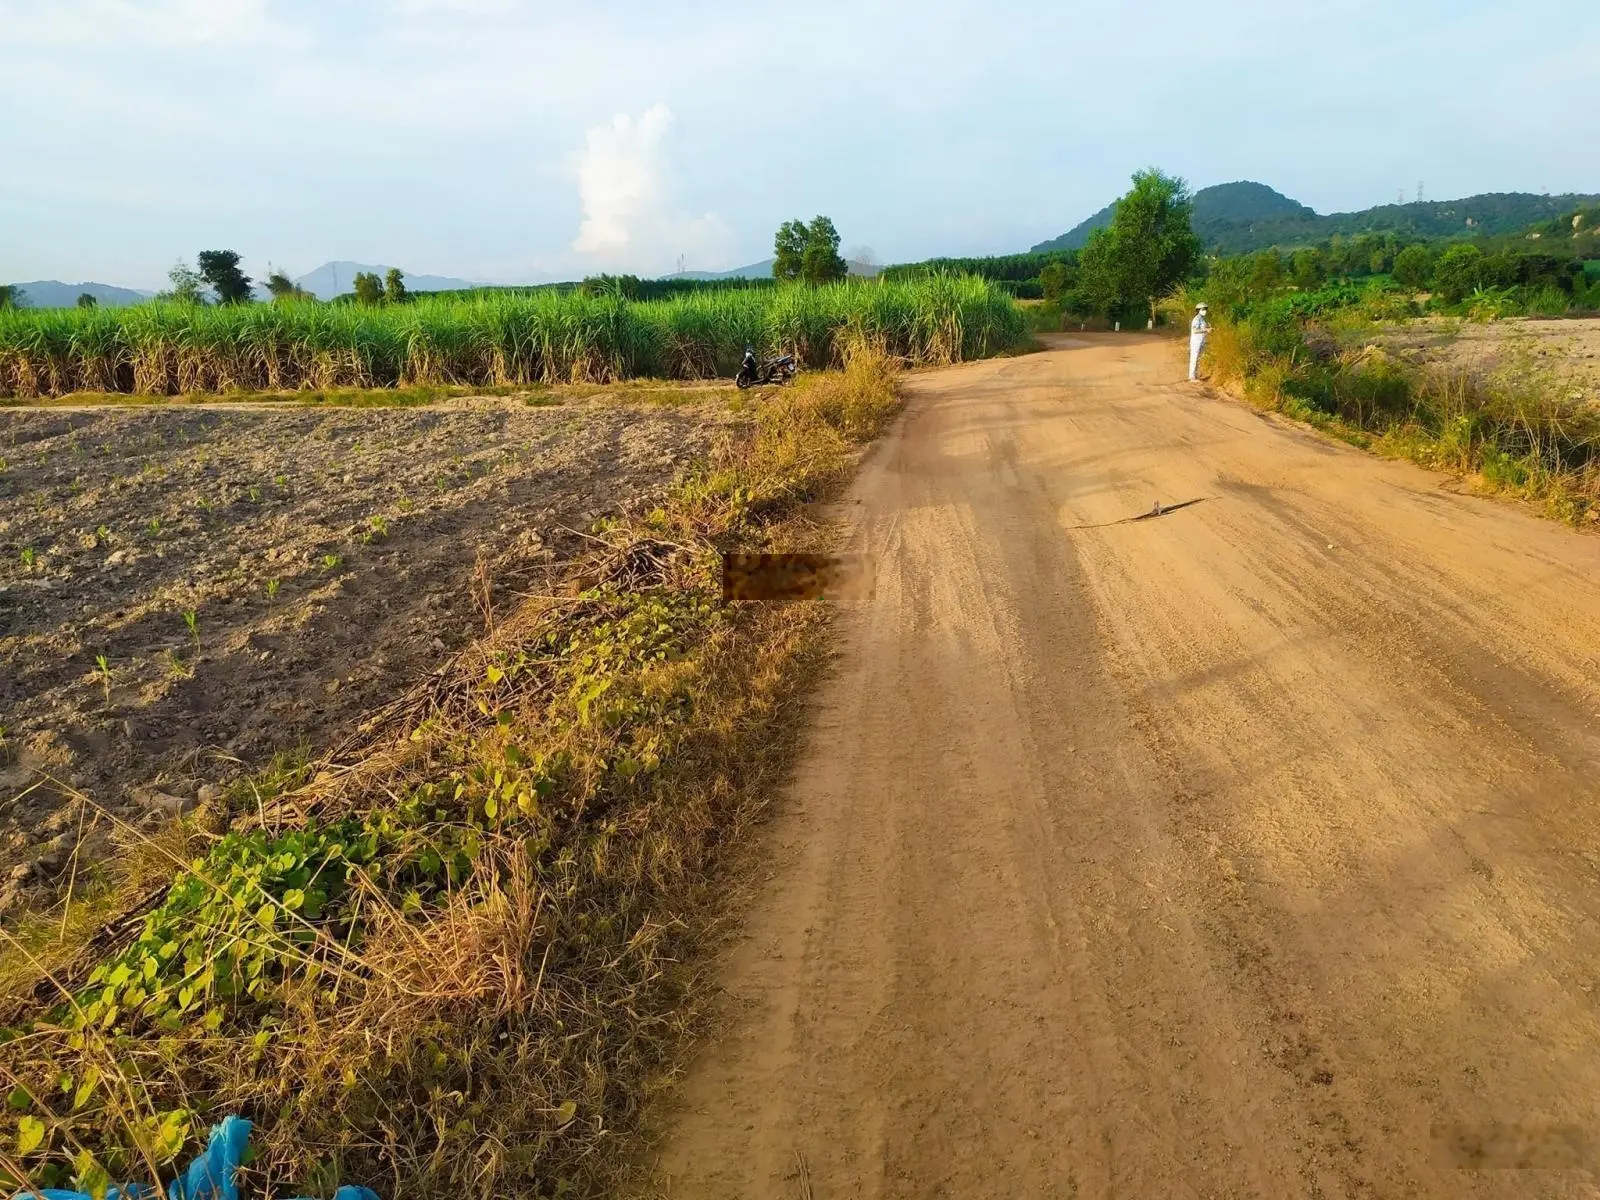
[0,277,1024,400]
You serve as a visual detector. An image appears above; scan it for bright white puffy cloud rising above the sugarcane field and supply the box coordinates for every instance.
[573,104,733,274]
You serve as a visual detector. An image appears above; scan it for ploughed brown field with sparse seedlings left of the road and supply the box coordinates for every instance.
[0,398,726,907]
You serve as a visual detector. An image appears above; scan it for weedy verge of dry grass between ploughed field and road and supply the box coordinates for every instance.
[0,347,898,1197]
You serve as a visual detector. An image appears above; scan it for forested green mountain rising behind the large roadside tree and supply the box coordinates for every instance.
[1034,182,1597,254]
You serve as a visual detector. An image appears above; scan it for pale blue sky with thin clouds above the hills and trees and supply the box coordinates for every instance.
[0,0,1600,286]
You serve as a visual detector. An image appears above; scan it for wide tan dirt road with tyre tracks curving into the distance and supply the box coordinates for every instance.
[656,336,1600,1200]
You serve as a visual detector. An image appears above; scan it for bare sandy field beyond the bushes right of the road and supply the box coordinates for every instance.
[1381,317,1600,402]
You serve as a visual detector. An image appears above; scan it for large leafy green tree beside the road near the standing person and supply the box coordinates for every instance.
[1080,168,1200,320]
